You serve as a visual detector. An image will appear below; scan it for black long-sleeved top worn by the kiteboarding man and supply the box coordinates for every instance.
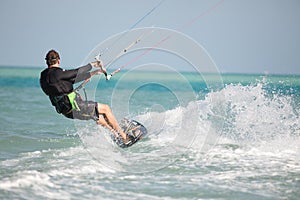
[40,64,92,98]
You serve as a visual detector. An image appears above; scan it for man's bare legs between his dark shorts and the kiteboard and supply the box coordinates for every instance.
[97,103,127,142]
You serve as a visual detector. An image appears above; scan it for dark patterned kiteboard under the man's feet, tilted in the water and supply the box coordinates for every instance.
[112,118,148,148]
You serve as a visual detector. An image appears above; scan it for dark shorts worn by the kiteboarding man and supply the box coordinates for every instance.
[64,94,99,121]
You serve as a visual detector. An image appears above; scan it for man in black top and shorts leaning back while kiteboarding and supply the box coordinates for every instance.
[40,50,129,144]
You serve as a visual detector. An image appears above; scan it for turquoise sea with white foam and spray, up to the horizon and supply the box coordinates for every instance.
[0,67,300,199]
